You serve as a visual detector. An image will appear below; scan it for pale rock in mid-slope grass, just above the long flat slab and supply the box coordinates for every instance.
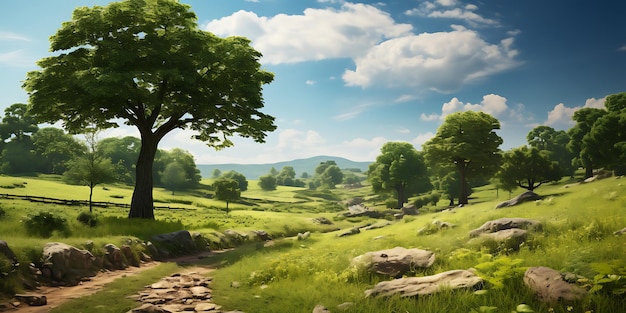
[352,247,435,277]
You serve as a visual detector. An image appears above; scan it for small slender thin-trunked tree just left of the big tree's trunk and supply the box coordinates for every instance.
[63,131,115,213]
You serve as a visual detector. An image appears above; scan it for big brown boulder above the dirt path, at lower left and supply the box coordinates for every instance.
[41,242,96,285]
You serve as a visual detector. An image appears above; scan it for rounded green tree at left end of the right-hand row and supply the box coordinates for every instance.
[368,142,430,208]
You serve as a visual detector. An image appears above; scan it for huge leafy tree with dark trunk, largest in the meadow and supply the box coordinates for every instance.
[24,0,276,219]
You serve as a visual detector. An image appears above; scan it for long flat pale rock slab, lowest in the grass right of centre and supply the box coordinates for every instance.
[365,270,483,297]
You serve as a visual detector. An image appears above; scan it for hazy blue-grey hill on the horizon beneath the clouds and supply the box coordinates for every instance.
[197,155,372,180]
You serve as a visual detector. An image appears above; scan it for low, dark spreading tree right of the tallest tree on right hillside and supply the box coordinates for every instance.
[498,146,562,191]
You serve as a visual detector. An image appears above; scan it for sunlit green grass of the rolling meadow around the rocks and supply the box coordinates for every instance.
[0,172,626,313]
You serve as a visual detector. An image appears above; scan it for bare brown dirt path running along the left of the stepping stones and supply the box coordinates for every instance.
[6,251,220,313]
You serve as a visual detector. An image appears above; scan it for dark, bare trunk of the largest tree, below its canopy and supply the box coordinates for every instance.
[128,132,159,219]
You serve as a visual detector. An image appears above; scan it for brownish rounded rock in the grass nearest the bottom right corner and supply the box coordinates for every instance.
[524,266,587,303]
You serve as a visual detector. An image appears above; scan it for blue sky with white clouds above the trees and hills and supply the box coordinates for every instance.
[0,0,626,164]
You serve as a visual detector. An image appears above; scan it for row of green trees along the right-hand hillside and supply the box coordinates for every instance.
[368,93,626,207]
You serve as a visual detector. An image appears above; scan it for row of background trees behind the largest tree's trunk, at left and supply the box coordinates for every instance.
[0,103,201,191]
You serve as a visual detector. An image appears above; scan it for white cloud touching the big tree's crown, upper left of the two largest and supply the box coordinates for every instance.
[204,2,412,64]
